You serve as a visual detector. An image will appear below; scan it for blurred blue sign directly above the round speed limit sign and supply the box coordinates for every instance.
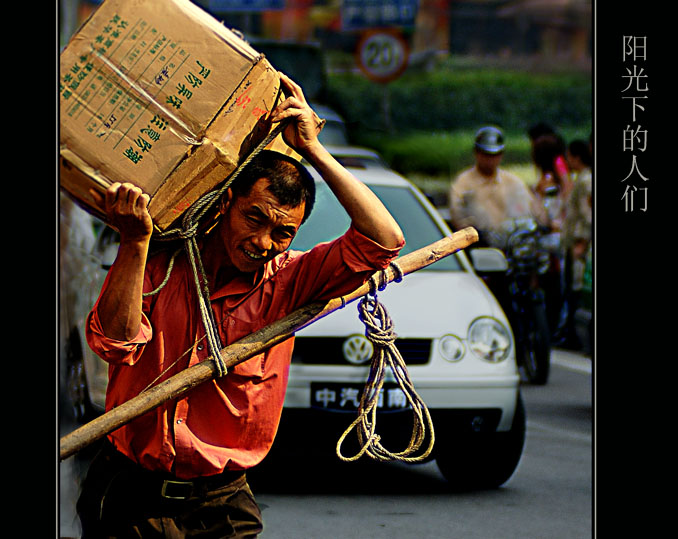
[341,0,419,30]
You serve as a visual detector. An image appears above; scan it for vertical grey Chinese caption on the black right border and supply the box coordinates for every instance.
[621,36,650,212]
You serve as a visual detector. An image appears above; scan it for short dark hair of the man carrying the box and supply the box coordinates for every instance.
[231,150,315,223]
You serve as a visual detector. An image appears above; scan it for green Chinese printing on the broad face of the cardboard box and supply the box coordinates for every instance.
[59,14,212,169]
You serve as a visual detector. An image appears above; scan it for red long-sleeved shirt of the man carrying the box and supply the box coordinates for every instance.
[87,227,400,478]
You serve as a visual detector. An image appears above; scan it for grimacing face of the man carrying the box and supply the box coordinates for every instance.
[219,178,305,273]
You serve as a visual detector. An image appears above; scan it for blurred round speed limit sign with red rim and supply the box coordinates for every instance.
[356,30,409,82]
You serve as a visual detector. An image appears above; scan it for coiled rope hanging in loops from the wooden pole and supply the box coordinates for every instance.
[336,262,435,463]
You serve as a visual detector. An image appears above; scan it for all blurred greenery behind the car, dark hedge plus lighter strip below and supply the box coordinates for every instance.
[327,69,592,176]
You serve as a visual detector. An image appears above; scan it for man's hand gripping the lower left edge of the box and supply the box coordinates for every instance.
[90,183,153,242]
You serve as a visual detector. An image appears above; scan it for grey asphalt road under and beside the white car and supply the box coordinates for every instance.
[58,350,593,539]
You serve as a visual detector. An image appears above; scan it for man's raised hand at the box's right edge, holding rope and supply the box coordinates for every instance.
[271,73,325,155]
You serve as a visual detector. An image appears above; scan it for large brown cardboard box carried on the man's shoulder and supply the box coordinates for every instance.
[59,0,296,231]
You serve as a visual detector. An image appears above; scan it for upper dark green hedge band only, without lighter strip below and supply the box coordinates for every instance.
[328,69,592,131]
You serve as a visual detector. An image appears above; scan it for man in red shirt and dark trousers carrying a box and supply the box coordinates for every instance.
[78,74,404,539]
